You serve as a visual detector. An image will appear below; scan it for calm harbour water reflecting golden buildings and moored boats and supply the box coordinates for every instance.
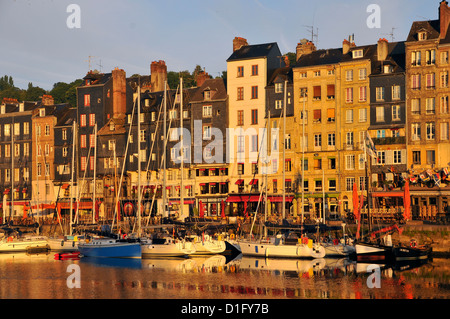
[0,252,450,299]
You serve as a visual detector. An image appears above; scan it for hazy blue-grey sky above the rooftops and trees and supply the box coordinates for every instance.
[0,0,440,90]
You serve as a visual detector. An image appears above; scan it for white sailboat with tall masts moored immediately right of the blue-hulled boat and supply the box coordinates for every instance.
[138,78,196,258]
